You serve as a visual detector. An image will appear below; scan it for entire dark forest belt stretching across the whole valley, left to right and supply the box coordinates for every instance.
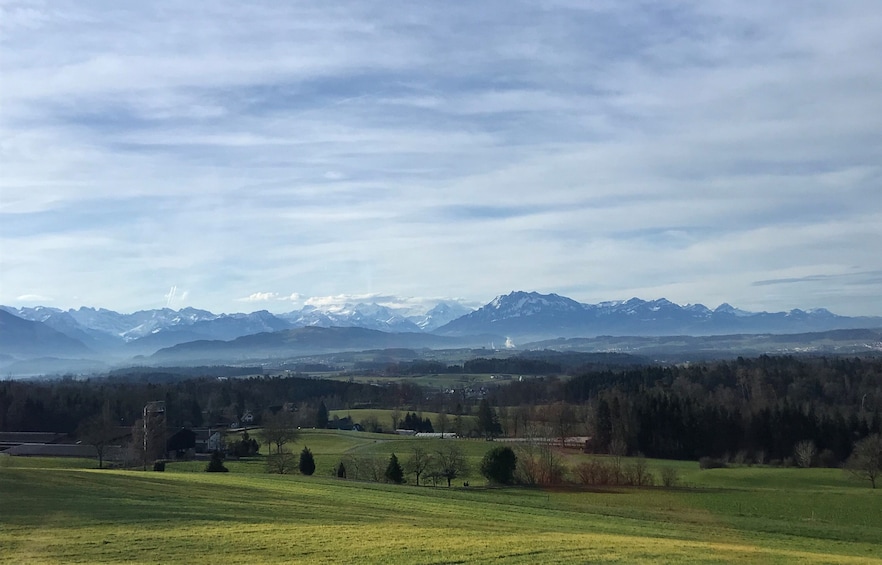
[0,353,882,465]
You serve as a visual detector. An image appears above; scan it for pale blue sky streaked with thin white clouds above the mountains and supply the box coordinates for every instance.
[0,0,882,315]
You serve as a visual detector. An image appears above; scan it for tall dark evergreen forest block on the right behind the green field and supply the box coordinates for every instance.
[492,356,882,465]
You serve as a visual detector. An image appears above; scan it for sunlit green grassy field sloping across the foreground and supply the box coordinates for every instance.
[0,431,882,564]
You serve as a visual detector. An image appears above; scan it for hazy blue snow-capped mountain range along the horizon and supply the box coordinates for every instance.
[0,291,882,365]
